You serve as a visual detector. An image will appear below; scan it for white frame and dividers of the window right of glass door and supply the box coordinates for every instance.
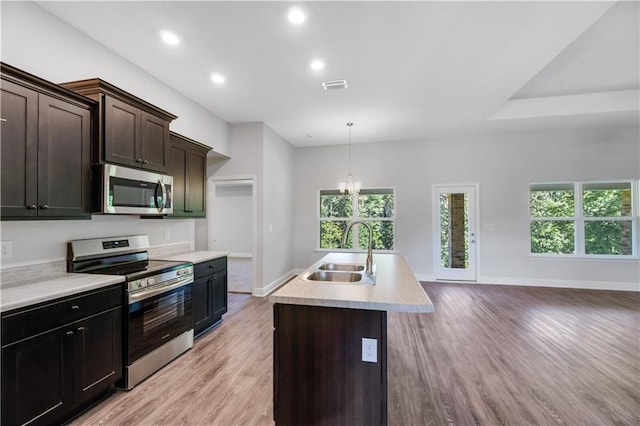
[527,179,640,260]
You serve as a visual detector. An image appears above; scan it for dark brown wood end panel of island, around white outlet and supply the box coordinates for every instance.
[273,303,387,425]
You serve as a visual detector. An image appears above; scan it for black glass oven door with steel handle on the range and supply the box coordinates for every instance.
[127,275,193,365]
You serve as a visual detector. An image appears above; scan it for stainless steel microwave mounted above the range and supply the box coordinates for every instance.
[98,164,173,215]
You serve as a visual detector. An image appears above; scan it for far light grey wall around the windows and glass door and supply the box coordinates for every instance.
[294,123,640,290]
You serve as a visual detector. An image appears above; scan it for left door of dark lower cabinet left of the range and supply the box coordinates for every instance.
[2,329,73,425]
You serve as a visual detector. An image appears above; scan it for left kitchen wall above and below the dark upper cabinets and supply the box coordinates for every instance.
[0,2,229,267]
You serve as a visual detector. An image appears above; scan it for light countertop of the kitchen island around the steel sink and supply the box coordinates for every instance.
[269,253,434,312]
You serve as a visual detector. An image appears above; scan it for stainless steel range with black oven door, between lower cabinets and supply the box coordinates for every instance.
[67,235,193,390]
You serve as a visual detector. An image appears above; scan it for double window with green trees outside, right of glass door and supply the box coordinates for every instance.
[529,182,637,256]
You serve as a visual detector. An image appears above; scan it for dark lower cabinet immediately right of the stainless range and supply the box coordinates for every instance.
[193,257,227,337]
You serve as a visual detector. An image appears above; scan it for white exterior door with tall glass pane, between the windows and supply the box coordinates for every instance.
[433,184,478,281]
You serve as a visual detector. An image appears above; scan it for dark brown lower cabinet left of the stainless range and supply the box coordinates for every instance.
[2,289,122,426]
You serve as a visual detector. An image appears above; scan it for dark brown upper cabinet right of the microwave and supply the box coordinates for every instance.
[169,132,211,218]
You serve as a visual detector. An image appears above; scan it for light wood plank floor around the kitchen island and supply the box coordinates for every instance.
[73,283,640,426]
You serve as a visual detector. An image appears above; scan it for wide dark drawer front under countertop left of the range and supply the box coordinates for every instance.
[2,284,124,346]
